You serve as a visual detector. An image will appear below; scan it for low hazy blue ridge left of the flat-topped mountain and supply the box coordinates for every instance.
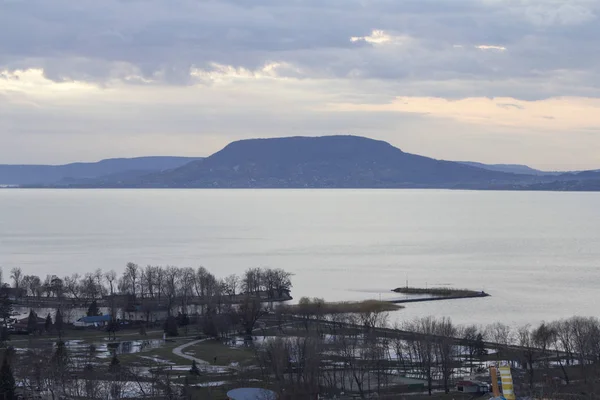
[0,156,199,185]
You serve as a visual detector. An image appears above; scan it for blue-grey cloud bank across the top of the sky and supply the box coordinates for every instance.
[0,0,600,98]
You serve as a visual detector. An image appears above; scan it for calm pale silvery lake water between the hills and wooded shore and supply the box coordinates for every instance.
[0,189,600,324]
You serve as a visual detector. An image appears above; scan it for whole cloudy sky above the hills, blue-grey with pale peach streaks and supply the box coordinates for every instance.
[0,0,600,170]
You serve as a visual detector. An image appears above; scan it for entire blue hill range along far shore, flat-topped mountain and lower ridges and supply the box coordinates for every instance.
[8,135,600,191]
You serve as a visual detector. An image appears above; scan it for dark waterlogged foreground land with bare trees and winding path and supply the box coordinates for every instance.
[0,264,600,400]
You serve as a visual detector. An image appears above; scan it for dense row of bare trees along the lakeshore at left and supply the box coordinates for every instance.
[0,262,292,300]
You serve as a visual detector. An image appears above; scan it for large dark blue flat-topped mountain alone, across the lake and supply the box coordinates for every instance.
[69,136,535,188]
